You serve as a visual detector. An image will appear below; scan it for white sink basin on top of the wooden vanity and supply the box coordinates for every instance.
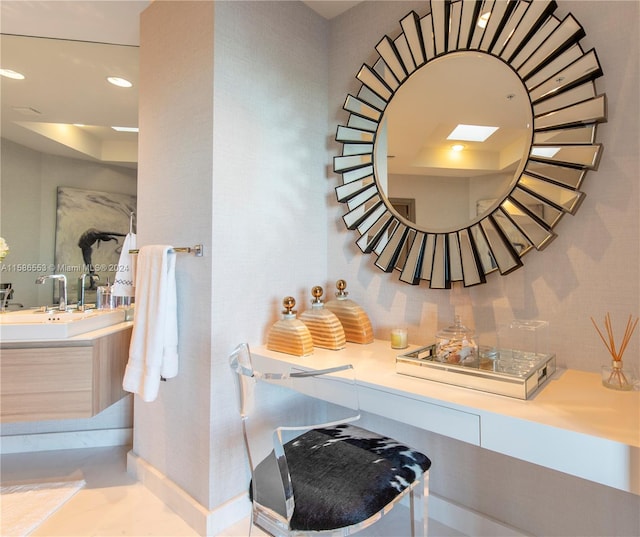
[0,309,125,341]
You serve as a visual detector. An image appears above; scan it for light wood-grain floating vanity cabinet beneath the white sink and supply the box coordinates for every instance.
[0,323,133,423]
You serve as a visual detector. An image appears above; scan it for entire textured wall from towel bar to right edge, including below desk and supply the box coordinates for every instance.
[134,1,638,535]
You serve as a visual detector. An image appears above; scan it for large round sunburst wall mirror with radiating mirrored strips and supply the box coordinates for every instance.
[334,0,607,289]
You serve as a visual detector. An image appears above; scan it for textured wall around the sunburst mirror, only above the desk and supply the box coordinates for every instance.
[328,1,640,371]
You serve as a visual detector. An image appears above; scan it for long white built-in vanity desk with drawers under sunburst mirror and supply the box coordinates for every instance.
[251,340,640,495]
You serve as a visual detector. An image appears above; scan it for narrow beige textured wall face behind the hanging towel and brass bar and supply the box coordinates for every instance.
[133,2,215,505]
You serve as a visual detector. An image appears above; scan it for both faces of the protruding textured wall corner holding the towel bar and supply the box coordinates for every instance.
[134,2,330,524]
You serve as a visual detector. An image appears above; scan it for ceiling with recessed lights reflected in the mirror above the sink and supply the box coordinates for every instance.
[0,34,139,165]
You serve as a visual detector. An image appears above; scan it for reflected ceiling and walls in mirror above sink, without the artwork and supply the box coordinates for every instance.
[0,34,139,307]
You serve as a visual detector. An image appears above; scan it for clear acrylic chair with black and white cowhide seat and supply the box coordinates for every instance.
[229,344,431,537]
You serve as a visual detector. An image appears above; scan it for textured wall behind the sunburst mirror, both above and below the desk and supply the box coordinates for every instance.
[327,1,640,536]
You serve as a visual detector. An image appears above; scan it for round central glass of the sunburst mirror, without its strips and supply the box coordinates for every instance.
[374,51,533,232]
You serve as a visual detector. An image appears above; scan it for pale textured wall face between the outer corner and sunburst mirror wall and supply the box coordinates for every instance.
[211,1,329,505]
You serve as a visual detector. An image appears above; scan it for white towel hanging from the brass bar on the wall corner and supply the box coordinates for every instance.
[122,245,178,402]
